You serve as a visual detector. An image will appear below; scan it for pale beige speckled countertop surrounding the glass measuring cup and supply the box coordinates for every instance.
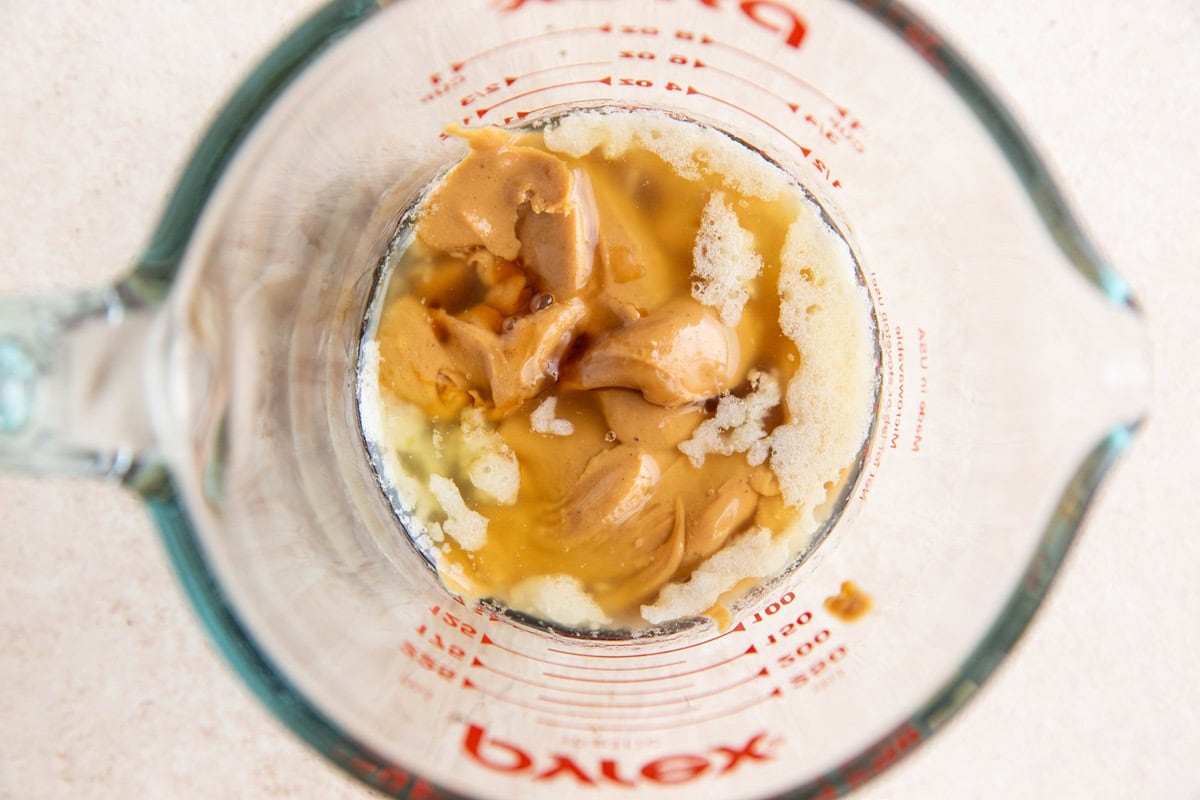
[0,0,1200,800]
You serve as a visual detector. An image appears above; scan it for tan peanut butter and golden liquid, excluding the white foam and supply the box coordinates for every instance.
[377,109,868,626]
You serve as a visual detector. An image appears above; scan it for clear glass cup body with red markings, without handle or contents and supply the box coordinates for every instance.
[42,0,1146,798]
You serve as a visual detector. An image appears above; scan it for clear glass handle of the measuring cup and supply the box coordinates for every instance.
[0,283,155,481]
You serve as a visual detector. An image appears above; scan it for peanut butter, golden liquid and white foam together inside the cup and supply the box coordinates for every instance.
[371,112,874,627]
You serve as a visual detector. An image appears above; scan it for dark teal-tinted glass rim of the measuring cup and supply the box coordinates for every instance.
[128,0,1140,800]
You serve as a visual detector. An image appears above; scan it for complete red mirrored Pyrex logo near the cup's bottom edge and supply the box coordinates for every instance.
[462,724,770,789]
